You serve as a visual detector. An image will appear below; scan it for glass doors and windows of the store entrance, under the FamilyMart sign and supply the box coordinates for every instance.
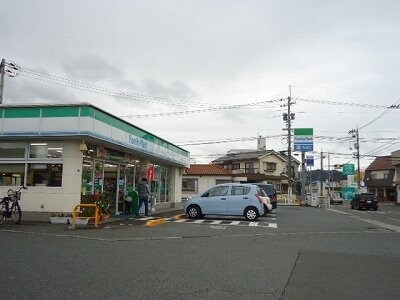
[81,146,171,215]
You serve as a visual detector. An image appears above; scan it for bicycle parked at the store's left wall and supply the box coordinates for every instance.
[0,186,28,225]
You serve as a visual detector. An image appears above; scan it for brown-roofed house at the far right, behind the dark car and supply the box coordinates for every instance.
[364,155,400,202]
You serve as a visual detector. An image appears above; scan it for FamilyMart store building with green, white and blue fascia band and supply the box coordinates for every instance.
[0,103,190,214]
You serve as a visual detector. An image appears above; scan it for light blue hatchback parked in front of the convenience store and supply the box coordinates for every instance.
[184,183,264,221]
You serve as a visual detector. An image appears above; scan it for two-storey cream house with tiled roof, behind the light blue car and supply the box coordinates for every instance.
[212,148,300,193]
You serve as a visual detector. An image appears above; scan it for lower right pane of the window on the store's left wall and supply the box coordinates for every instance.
[27,163,63,186]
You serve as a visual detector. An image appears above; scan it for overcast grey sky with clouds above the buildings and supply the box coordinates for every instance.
[0,0,400,168]
